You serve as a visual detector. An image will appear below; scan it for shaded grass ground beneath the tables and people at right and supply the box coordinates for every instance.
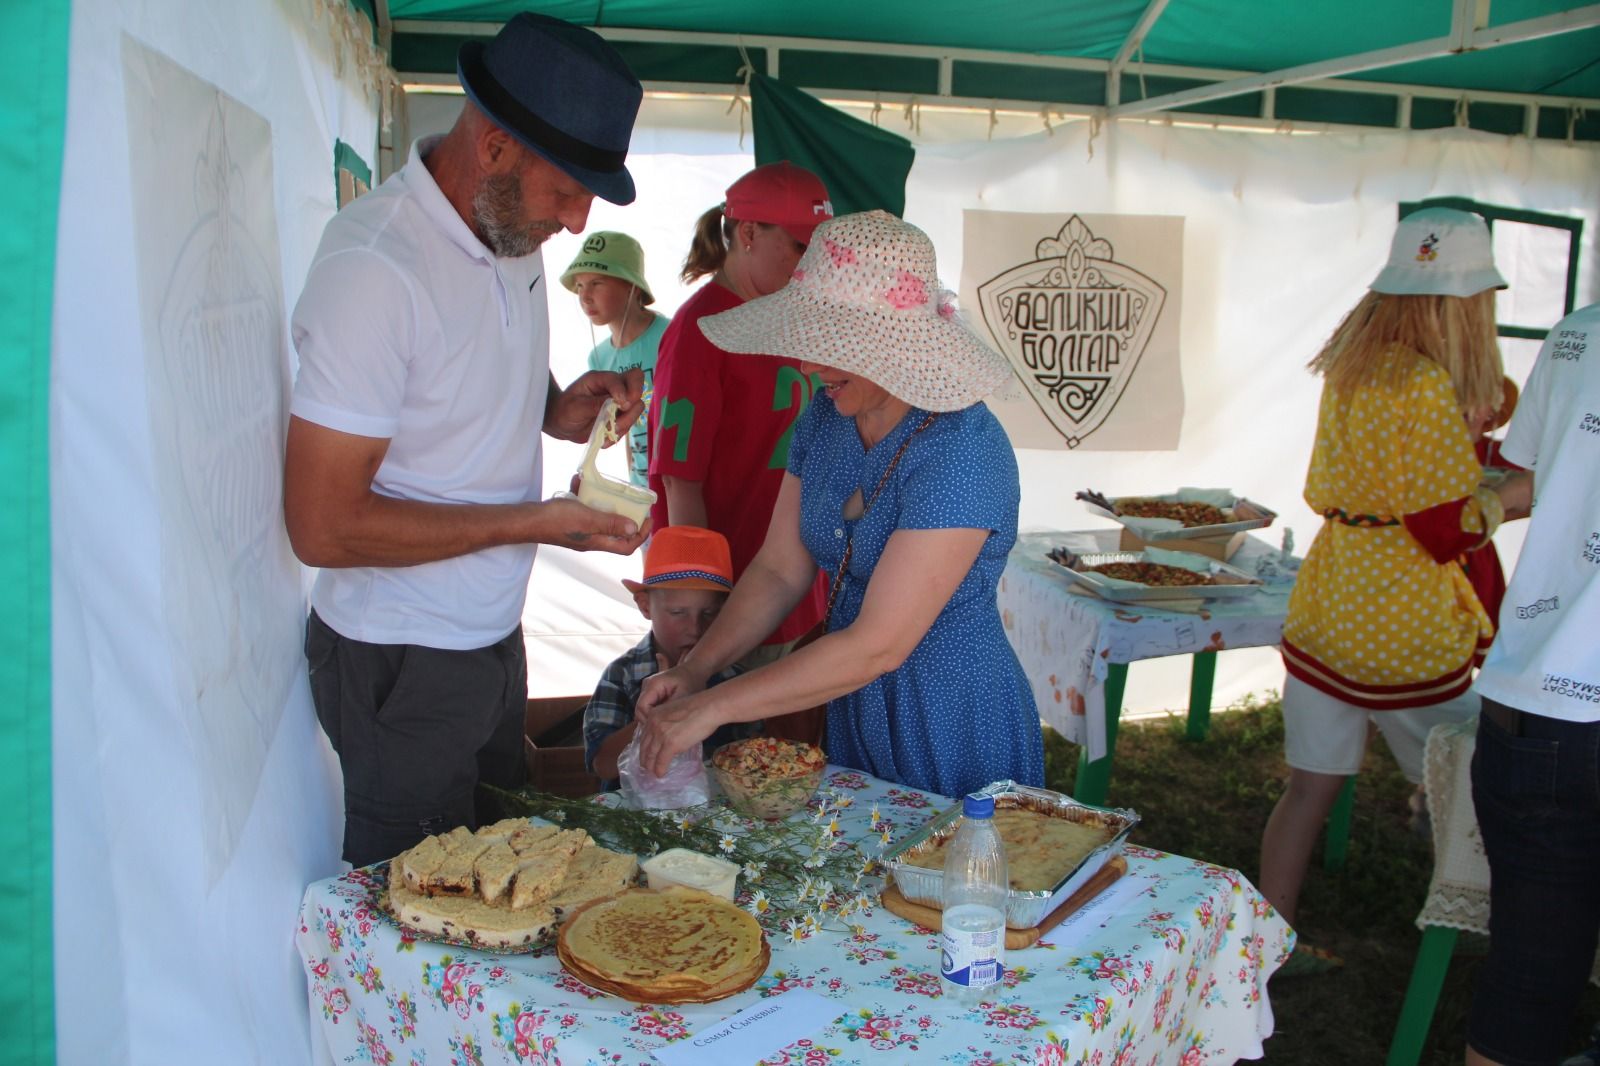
[1045,701,1600,1066]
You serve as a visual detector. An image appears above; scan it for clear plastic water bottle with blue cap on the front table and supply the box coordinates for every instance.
[939,792,1010,1007]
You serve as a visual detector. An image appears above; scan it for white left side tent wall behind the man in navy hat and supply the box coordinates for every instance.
[51,0,378,1064]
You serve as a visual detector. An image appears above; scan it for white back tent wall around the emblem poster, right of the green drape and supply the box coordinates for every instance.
[906,122,1600,712]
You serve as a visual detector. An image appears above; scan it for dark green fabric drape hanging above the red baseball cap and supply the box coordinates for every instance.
[750,74,917,214]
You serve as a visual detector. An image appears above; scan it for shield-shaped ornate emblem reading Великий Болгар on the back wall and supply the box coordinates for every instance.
[978,214,1166,448]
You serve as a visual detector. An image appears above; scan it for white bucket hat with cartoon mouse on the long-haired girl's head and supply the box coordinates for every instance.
[1371,208,1506,296]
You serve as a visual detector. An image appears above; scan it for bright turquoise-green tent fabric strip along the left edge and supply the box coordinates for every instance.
[0,0,72,1063]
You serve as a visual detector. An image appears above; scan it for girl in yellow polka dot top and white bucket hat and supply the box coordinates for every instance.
[1261,208,1506,972]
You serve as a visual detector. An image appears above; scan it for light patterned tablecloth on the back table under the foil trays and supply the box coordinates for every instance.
[998,530,1298,759]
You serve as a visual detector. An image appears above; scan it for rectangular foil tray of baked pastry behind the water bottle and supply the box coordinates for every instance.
[882,781,1139,928]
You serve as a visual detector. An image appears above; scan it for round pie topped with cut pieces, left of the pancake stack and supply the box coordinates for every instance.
[389,818,638,949]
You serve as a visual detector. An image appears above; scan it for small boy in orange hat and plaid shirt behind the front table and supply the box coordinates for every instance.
[584,525,762,791]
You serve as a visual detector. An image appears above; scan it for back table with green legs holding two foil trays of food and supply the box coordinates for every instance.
[998,490,1299,802]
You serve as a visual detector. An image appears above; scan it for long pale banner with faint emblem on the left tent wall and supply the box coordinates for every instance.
[122,37,304,882]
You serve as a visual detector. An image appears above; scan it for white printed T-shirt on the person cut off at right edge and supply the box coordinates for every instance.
[1477,304,1600,722]
